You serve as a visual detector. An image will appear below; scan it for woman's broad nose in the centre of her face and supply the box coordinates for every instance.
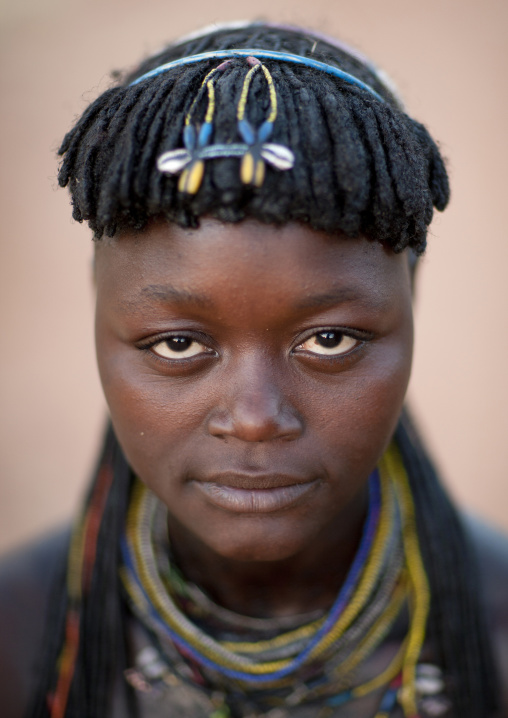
[208,363,304,442]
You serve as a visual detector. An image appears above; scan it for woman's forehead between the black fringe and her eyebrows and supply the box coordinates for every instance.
[96,219,409,304]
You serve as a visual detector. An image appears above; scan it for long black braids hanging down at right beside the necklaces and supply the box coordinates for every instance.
[395,412,497,718]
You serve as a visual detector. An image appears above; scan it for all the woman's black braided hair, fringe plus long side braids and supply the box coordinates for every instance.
[29,23,496,718]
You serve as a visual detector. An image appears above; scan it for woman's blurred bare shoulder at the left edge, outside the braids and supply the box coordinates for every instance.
[0,528,70,718]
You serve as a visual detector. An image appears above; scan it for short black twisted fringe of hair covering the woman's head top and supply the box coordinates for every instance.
[59,24,449,253]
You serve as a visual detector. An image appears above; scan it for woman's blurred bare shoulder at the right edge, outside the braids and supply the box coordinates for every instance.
[464,516,508,718]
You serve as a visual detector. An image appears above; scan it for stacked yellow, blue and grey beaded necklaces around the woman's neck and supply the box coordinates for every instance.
[122,446,436,718]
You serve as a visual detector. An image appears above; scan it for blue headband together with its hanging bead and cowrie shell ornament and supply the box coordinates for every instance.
[131,48,392,195]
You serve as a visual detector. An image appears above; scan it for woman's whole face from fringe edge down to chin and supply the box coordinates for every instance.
[96,219,412,561]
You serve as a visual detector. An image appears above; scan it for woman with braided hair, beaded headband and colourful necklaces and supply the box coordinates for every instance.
[1,23,508,718]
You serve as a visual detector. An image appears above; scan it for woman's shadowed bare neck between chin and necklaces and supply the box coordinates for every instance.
[168,490,368,618]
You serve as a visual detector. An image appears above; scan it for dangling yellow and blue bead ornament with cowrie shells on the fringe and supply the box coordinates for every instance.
[157,56,294,194]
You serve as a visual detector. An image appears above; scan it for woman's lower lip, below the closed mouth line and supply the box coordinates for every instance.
[195,480,318,514]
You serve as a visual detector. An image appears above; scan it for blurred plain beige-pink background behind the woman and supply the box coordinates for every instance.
[0,0,508,550]
